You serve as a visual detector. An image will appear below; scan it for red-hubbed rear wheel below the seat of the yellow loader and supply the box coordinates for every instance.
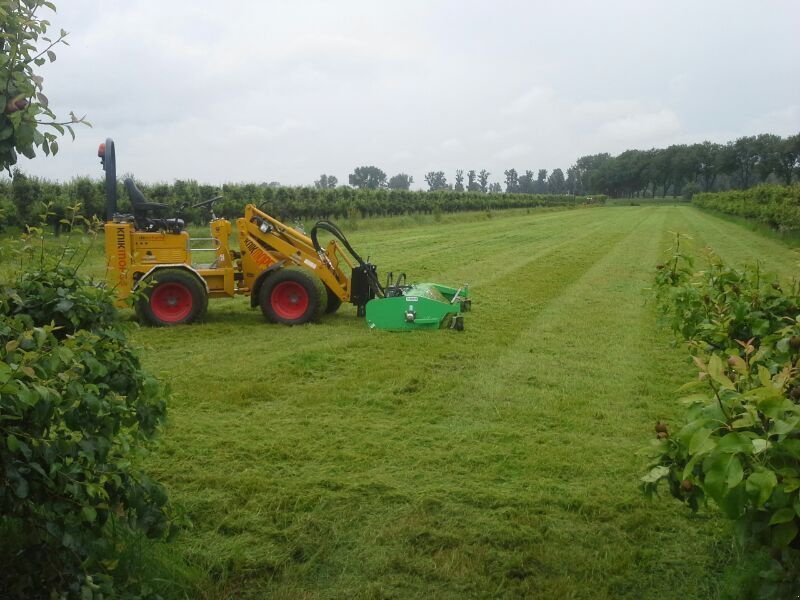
[136,269,208,327]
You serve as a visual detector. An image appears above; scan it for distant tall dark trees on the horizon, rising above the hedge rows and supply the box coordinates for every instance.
[324,133,800,197]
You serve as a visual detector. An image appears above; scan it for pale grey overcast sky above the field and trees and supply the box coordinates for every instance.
[14,0,800,188]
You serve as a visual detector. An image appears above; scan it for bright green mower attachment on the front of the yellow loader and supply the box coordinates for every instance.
[366,273,472,331]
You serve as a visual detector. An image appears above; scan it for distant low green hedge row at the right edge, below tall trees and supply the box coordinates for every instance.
[692,184,800,231]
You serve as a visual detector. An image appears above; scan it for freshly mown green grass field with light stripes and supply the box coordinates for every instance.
[6,206,800,599]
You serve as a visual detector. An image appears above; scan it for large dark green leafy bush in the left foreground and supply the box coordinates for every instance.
[0,234,170,598]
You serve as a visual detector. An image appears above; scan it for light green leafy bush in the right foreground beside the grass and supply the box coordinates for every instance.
[642,237,800,596]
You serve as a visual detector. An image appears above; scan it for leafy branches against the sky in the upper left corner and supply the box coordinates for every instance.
[0,0,88,169]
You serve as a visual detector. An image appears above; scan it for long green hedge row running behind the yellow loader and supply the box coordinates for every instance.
[0,171,604,228]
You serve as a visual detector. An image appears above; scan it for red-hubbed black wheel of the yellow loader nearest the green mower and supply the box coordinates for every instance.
[258,267,328,325]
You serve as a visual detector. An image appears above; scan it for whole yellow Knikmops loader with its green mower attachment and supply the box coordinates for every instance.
[98,138,471,331]
